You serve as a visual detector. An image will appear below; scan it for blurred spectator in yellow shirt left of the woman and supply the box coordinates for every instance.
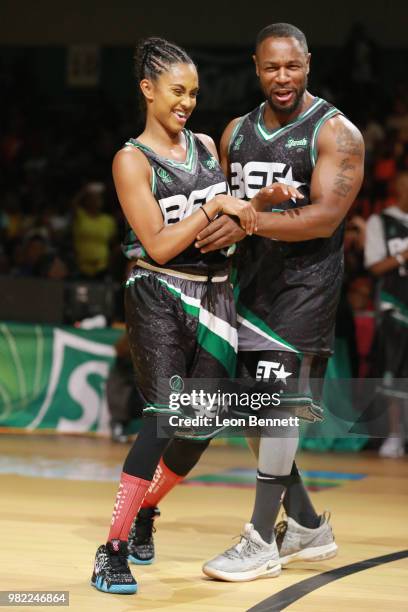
[73,183,117,279]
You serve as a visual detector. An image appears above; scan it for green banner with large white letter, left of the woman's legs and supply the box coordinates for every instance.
[0,323,121,433]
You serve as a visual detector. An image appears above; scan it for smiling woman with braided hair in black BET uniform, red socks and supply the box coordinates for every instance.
[91,38,257,593]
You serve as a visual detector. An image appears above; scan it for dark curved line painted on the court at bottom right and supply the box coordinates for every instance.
[247,549,408,612]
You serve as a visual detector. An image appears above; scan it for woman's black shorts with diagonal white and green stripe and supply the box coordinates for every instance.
[125,267,237,414]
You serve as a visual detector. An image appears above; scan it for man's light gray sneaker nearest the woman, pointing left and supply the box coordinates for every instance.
[203,523,281,582]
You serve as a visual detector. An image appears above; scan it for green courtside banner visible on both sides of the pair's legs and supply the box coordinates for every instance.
[0,322,365,450]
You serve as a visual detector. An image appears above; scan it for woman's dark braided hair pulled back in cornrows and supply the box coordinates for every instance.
[134,37,195,111]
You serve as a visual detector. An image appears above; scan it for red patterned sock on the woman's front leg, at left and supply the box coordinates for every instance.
[108,472,151,541]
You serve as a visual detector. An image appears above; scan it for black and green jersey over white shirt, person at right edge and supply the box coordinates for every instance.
[380,210,408,326]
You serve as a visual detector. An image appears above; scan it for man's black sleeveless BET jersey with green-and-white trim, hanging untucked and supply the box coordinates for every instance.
[229,98,343,355]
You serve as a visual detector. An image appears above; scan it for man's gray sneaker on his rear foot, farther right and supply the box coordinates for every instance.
[275,512,337,566]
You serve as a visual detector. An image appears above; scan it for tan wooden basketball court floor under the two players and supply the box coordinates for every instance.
[0,435,408,612]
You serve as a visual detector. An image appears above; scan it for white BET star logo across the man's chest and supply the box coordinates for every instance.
[231,161,303,200]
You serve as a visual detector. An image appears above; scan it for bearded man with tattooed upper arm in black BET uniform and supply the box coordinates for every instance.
[196,24,364,581]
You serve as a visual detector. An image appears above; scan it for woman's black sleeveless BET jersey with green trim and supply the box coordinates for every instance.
[122,130,228,273]
